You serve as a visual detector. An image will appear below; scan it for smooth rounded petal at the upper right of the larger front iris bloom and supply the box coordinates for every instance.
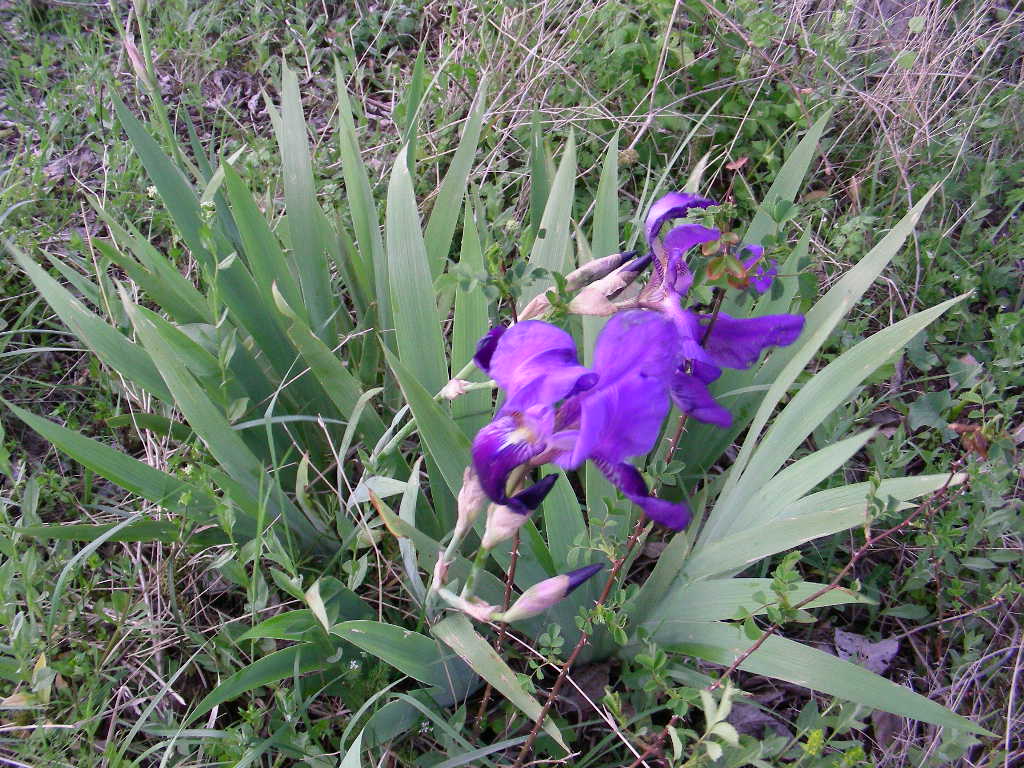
[594,309,681,387]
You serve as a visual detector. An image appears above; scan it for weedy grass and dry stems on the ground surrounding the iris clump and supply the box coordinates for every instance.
[0,0,1024,766]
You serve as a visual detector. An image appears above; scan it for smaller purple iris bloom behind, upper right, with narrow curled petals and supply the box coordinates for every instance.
[640,193,804,428]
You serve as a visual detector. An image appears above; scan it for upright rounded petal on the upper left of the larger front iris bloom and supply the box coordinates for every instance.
[484,321,597,413]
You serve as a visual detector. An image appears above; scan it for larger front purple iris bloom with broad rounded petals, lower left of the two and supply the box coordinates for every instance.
[473,310,690,530]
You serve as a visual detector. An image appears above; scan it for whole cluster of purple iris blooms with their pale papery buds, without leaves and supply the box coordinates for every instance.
[435,193,804,621]
